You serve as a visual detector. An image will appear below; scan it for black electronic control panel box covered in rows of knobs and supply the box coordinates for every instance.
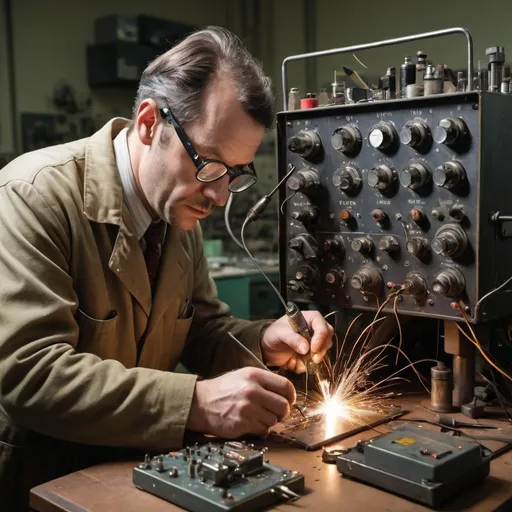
[278,92,512,322]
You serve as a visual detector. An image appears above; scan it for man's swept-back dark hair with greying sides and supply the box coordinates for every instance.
[133,27,274,128]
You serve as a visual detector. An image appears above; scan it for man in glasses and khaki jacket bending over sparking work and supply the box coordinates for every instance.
[0,28,332,510]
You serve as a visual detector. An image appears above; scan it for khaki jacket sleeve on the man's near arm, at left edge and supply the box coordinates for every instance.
[0,180,196,450]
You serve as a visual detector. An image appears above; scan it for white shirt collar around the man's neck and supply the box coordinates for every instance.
[114,128,152,240]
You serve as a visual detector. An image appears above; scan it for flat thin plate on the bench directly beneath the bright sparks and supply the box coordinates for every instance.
[270,405,407,450]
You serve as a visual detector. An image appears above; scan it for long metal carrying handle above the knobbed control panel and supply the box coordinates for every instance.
[281,27,473,110]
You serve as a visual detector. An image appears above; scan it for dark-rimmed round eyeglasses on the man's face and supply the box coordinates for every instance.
[160,108,258,193]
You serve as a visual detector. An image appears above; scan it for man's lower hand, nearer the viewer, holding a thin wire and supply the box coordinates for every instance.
[187,367,296,439]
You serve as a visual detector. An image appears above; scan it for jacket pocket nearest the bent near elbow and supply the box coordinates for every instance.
[75,309,119,357]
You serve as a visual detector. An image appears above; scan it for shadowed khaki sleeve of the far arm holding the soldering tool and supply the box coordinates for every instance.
[181,227,271,377]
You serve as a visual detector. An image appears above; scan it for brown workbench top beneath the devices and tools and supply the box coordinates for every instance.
[30,399,512,512]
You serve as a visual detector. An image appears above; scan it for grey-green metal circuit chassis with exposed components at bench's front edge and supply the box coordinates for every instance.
[133,441,304,512]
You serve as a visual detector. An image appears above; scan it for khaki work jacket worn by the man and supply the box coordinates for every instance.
[0,119,266,510]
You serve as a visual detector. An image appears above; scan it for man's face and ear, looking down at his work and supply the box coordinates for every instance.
[130,80,265,231]
